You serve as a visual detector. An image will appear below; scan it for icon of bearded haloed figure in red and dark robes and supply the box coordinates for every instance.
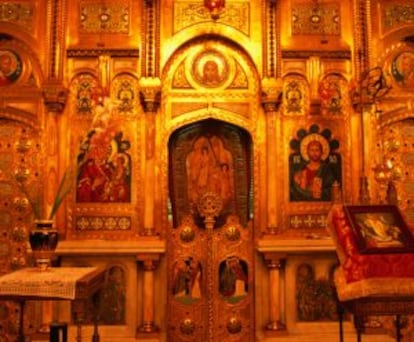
[290,133,341,201]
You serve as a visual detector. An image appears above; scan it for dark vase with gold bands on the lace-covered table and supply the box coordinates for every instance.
[29,220,59,271]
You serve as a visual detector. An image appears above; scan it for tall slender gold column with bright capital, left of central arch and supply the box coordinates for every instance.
[139,77,161,236]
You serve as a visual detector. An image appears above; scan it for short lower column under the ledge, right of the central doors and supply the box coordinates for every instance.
[263,253,286,333]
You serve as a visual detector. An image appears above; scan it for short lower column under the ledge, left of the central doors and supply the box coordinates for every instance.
[137,254,160,338]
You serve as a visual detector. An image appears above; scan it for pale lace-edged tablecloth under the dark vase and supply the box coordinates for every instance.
[0,267,97,299]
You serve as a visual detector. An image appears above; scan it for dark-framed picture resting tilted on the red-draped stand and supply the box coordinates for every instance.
[344,205,414,254]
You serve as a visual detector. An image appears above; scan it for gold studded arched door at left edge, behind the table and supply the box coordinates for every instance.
[0,118,41,340]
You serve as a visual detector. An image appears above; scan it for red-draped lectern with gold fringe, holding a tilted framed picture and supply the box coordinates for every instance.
[328,204,414,342]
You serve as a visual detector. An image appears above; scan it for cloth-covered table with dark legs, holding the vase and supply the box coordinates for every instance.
[0,267,105,342]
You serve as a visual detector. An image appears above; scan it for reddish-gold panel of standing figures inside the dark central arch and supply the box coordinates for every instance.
[186,135,234,207]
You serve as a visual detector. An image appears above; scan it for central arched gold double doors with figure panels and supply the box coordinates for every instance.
[167,121,254,342]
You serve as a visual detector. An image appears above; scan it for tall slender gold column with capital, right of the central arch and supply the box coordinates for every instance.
[262,77,282,234]
